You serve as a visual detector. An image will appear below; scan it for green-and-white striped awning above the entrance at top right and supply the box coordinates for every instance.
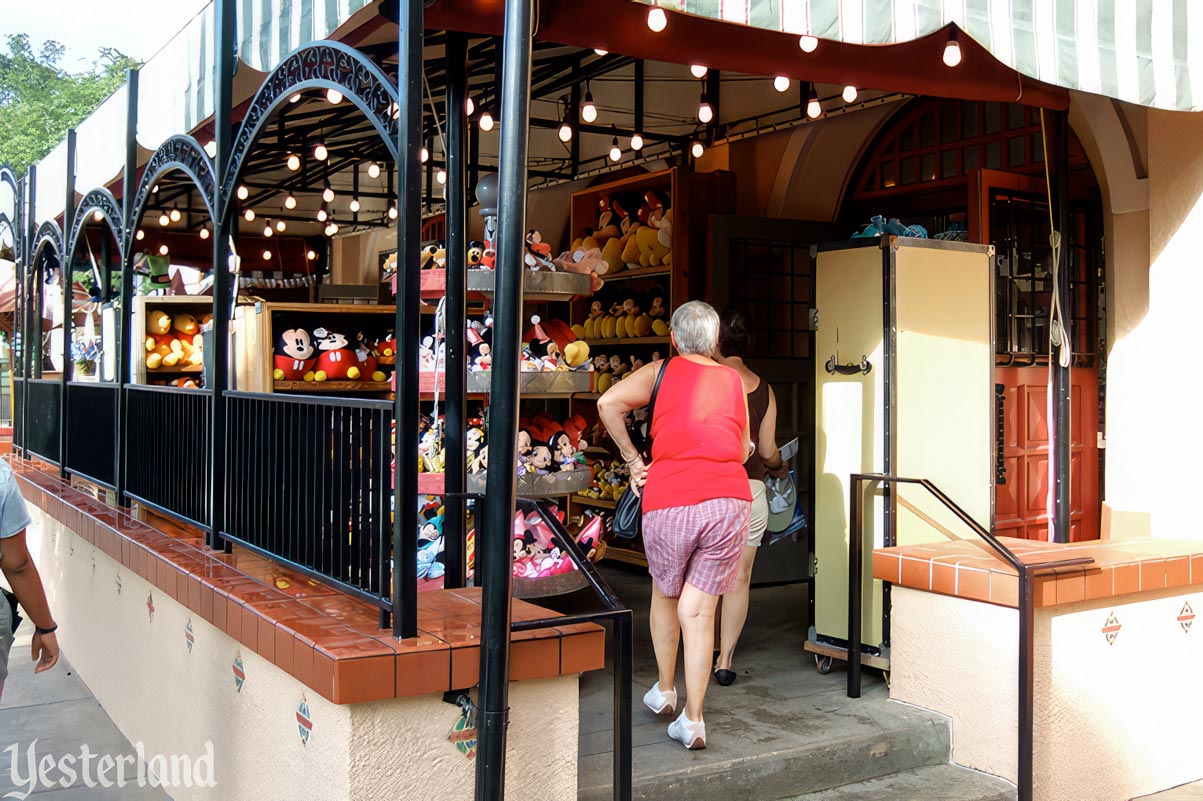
[639,0,1203,111]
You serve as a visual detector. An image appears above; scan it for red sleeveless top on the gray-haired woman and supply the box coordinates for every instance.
[644,358,752,512]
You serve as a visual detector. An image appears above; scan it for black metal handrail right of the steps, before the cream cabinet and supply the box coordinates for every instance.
[848,473,1095,801]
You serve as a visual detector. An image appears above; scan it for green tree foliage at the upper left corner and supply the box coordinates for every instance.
[0,34,137,174]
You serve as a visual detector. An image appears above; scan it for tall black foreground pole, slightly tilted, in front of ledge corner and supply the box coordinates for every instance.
[476,0,533,801]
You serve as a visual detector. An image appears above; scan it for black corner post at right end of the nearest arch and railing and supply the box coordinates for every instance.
[392,0,425,637]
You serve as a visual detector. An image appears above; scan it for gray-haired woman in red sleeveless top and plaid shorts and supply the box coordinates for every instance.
[598,301,752,748]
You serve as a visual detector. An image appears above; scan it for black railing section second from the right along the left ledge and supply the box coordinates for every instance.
[126,385,213,528]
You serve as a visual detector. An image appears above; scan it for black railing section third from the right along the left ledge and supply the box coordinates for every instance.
[64,381,117,488]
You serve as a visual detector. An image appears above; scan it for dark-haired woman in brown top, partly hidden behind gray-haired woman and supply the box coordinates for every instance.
[715,308,789,687]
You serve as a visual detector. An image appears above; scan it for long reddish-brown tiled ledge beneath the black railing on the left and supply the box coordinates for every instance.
[10,457,605,704]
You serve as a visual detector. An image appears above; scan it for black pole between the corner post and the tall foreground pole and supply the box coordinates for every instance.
[443,32,468,588]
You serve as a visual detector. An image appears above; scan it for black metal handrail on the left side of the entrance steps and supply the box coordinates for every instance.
[510,498,634,801]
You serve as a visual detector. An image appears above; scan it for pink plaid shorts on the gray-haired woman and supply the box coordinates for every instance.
[644,498,752,598]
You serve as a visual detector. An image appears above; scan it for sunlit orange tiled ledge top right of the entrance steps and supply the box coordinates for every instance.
[873,536,1203,606]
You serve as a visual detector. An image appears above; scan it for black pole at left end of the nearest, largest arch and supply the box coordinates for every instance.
[206,0,237,548]
